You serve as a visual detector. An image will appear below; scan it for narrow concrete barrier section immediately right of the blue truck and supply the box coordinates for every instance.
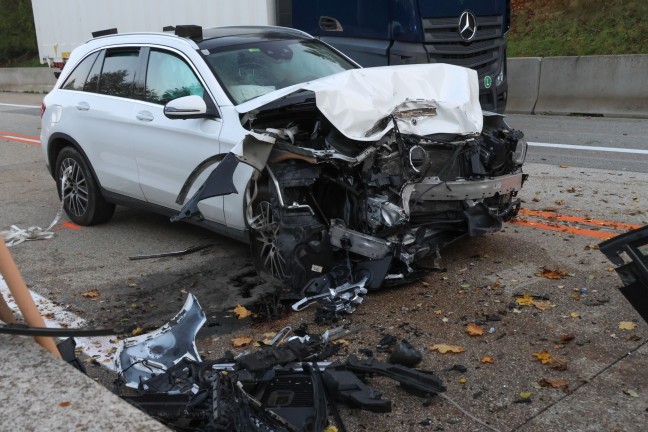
[506,57,542,114]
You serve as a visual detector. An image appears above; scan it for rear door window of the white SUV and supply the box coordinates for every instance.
[98,48,139,98]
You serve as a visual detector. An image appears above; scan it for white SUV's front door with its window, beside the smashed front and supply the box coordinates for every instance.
[133,48,225,223]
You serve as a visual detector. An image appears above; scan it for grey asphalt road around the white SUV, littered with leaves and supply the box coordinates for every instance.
[0,94,648,432]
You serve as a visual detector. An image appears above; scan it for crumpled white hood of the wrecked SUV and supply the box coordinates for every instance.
[236,63,483,141]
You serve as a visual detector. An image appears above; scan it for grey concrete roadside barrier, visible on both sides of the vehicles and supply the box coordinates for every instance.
[0,54,648,118]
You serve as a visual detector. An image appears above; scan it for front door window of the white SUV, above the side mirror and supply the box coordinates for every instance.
[144,50,205,105]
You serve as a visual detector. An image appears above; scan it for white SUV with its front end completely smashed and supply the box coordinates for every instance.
[41,26,526,295]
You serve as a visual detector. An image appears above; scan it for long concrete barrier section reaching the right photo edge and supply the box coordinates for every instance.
[532,55,648,117]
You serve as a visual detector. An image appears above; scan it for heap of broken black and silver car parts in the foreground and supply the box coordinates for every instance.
[115,295,445,432]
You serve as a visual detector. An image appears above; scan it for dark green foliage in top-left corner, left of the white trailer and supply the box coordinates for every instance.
[0,0,38,66]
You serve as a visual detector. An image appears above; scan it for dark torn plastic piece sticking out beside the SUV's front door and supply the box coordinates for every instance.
[171,153,239,222]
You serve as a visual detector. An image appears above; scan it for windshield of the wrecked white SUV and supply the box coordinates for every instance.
[203,39,356,105]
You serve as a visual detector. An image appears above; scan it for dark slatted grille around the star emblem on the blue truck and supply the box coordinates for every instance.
[423,16,505,78]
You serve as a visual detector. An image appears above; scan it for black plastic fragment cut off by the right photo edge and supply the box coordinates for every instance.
[599,225,648,323]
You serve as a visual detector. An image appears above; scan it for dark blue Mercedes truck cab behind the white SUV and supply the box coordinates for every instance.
[276,0,511,113]
